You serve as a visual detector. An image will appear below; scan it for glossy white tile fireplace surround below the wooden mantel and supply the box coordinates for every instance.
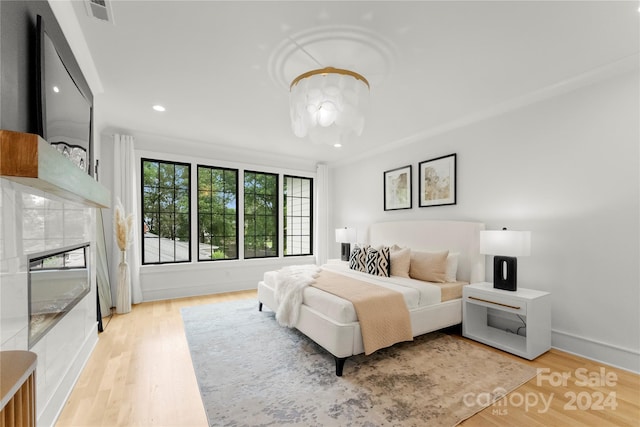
[0,178,98,425]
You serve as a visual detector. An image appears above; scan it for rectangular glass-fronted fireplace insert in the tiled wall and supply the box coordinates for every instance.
[28,243,90,348]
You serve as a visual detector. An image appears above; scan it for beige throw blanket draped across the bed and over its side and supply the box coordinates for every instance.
[311,270,413,354]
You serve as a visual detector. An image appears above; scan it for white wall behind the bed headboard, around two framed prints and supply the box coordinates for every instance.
[330,72,640,372]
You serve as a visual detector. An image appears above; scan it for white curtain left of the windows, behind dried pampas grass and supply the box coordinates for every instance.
[111,134,142,304]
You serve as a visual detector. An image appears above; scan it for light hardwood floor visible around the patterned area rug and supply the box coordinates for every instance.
[57,291,640,427]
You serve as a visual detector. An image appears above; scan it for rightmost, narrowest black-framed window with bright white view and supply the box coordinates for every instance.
[283,175,313,256]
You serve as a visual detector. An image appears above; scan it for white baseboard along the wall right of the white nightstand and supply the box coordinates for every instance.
[551,329,640,374]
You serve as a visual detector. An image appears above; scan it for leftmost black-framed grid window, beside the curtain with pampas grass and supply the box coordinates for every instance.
[142,159,191,264]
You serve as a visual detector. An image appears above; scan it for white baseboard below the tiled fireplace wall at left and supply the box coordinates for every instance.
[36,328,98,426]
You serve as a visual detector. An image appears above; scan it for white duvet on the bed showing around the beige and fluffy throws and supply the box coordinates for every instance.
[264,263,441,323]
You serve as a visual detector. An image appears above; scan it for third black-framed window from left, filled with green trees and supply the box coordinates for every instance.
[244,171,278,258]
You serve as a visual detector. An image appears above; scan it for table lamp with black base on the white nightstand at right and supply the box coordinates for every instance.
[480,228,531,291]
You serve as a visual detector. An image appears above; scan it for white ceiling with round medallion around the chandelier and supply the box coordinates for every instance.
[66,0,640,164]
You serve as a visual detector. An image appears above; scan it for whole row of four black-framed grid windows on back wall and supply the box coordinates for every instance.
[141,163,314,264]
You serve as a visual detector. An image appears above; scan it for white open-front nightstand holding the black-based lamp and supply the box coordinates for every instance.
[462,282,551,360]
